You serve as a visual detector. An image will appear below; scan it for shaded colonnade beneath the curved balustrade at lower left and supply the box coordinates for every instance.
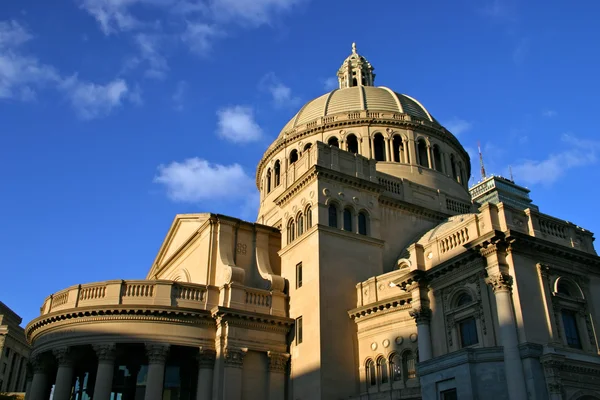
[26,343,289,400]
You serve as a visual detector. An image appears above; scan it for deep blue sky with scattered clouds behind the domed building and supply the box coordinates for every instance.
[0,0,600,323]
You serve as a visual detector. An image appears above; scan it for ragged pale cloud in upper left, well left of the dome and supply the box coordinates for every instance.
[61,76,131,119]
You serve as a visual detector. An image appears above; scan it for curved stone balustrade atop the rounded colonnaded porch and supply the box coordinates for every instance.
[40,280,286,316]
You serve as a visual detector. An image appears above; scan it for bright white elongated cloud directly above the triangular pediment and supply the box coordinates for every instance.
[154,158,255,203]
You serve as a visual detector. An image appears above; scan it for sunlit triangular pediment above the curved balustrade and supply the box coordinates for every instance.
[147,213,211,279]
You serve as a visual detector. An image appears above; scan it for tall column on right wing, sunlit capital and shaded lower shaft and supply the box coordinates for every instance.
[487,273,527,400]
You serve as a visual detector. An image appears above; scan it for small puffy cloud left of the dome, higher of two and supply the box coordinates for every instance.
[217,106,263,143]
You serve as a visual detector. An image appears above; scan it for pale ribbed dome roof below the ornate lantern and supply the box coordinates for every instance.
[282,86,438,132]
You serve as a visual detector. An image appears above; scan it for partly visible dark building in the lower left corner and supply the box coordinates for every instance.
[0,302,31,393]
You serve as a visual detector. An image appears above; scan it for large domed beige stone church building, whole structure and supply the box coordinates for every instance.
[26,46,600,400]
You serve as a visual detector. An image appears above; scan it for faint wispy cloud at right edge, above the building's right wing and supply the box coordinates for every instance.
[512,134,600,185]
